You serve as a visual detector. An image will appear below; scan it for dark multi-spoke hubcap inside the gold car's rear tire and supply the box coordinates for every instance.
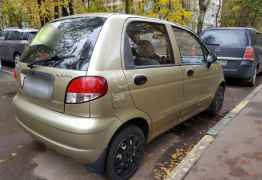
[114,135,143,177]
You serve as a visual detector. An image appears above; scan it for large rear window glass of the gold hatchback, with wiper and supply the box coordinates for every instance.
[21,17,106,70]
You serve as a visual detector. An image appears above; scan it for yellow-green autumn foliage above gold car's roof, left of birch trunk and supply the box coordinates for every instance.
[1,0,192,27]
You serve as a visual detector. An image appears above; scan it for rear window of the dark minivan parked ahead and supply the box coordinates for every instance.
[201,30,247,48]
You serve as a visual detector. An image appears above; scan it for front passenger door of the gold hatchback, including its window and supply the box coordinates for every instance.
[173,27,217,120]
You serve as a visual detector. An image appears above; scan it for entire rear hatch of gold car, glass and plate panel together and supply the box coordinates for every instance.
[16,16,105,115]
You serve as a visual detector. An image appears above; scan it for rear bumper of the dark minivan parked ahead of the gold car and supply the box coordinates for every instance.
[223,61,256,80]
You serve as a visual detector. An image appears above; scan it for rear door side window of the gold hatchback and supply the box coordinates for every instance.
[125,22,174,66]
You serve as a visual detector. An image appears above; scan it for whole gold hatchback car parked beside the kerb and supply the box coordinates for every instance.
[14,14,225,180]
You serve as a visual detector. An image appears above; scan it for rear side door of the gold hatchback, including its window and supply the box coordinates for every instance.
[124,19,183,135]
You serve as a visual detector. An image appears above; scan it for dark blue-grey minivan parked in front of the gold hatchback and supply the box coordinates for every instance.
[201,27,262,86]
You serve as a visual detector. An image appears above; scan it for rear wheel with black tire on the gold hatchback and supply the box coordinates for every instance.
[106,125,146,180]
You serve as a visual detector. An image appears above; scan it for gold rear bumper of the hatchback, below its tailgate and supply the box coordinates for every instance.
[14,95,119,164]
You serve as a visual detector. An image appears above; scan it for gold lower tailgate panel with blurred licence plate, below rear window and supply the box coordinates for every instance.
[17,63,86,112]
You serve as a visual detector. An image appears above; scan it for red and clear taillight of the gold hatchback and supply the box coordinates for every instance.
[65,76,108,104]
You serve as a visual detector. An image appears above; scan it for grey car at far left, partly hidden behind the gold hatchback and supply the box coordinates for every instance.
[0,28,37,62]
